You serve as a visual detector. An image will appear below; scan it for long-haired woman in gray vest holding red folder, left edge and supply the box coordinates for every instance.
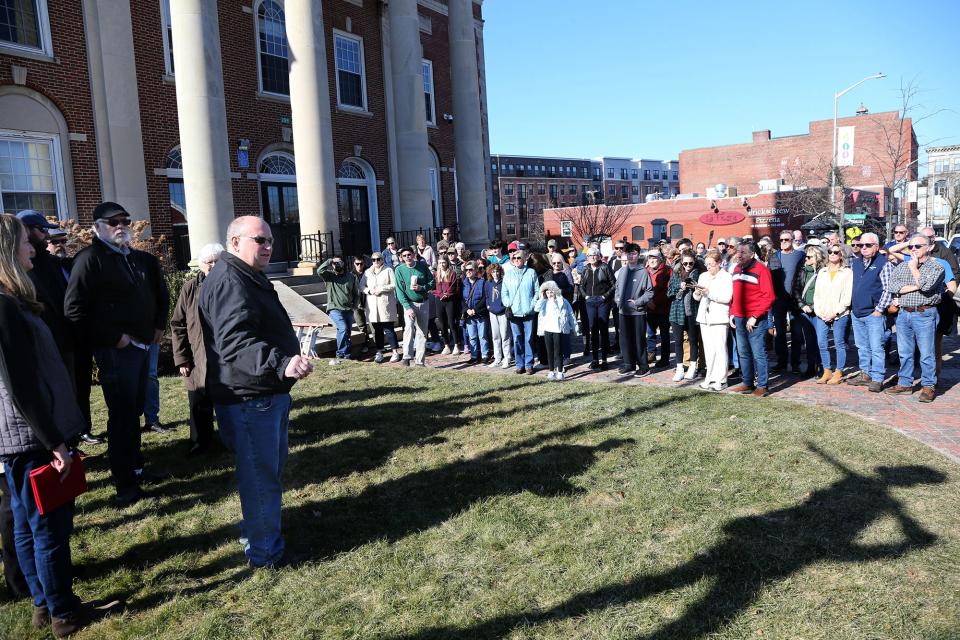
[0,214,91,637]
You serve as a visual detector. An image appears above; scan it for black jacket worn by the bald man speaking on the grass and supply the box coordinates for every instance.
[200,252,300,404]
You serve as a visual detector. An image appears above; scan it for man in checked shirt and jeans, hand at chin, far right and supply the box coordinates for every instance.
[887,233,944,402]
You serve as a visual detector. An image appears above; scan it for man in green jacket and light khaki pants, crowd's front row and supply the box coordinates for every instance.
[394,247,436,367]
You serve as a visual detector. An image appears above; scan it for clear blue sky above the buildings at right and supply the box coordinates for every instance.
[483,0,960,172]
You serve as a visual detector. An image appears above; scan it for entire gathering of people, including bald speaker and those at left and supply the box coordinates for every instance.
[0,202,958,637]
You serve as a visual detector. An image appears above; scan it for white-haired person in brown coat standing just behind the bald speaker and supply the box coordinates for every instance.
[170,243,223,455]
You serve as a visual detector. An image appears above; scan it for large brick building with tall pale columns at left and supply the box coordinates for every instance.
[0,0,492,260]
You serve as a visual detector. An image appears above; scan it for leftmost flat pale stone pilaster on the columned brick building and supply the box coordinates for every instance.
[82,0,150,222]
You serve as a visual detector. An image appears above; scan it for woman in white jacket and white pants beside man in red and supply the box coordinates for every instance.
[693,249,733,391]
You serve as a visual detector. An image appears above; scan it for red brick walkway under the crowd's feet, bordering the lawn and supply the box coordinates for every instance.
[396,336,960,462]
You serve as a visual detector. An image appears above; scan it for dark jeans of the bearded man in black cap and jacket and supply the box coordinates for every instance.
[93,344,149,496]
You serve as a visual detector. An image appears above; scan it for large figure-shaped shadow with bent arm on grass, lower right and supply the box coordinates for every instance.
[393,443,946,640]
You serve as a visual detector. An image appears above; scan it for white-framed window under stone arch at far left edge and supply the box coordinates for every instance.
[0,131,65,218]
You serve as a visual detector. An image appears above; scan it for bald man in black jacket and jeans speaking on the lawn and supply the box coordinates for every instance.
[200,216,313,567]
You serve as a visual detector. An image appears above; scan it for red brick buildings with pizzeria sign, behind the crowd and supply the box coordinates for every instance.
[544,112,918,246]
